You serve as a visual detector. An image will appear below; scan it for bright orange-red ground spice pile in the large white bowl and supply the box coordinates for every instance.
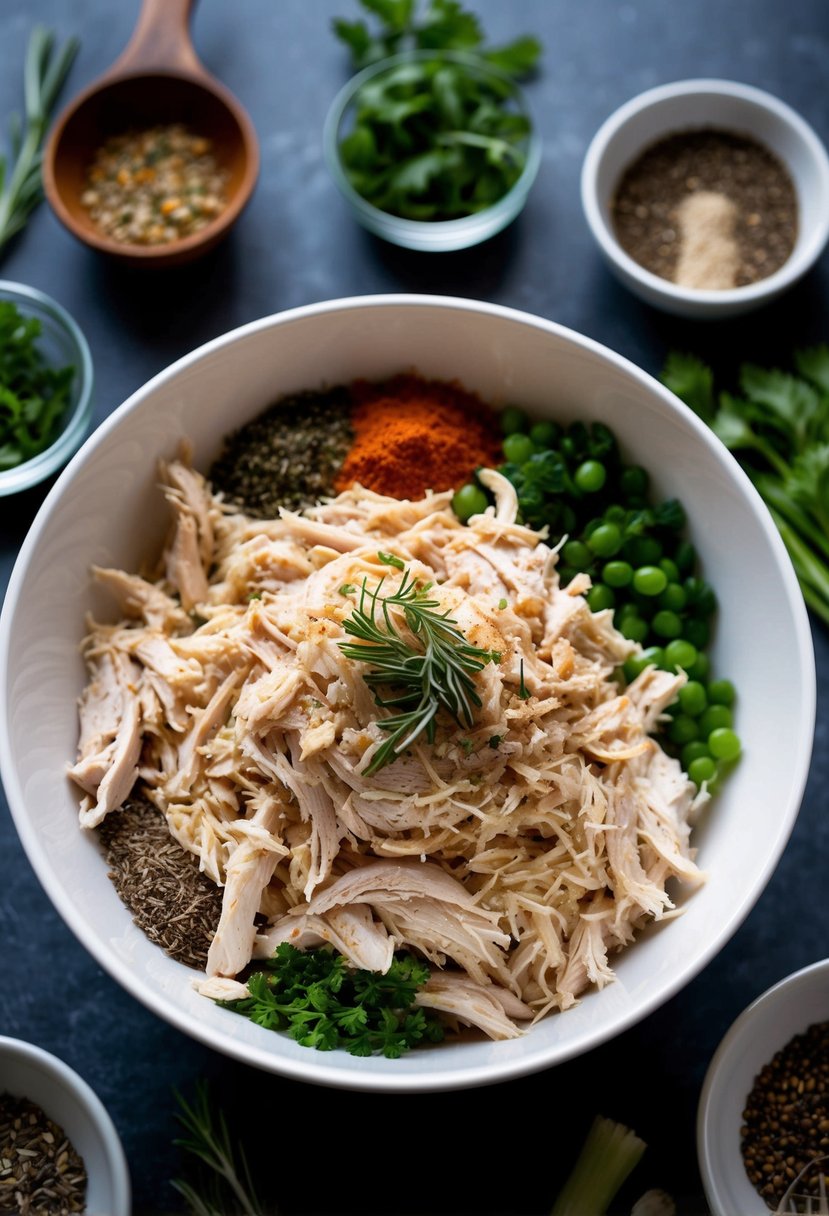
[337,375,500,499]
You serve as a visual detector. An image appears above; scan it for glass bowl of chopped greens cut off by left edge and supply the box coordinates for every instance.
[0,280,92,496]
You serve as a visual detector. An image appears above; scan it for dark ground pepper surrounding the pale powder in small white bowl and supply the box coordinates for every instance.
[611,129,797,287]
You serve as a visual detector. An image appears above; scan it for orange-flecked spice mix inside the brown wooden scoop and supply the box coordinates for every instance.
[80,123,227,244]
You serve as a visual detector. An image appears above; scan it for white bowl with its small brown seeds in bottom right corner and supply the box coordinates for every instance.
[697,959,829,1216]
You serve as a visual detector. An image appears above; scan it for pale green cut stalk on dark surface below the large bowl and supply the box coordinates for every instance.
[551,1115,647,1216]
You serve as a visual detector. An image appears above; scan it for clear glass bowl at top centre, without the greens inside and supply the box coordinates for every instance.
[322,51,541,253]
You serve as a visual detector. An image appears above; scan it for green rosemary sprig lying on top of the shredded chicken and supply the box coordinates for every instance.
[339,553,501,776]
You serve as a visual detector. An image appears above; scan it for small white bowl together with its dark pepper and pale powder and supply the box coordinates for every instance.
[581,80,829,320]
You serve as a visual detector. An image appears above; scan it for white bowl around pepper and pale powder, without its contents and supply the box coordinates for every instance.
[581,80,829,320]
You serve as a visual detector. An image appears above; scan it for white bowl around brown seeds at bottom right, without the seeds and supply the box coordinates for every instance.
[697,958,829,1216]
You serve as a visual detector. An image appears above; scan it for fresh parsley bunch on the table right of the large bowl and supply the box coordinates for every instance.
[662,345,829,624]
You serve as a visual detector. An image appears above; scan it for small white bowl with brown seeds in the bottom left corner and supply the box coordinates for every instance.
[0,1035,130,1216]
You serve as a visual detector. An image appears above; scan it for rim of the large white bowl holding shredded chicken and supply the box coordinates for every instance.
[0,293,817,1093]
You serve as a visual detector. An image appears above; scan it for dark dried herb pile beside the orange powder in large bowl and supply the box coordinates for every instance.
[208,385,354,519]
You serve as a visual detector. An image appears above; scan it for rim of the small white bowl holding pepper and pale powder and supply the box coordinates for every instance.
[581,77,829,313]
